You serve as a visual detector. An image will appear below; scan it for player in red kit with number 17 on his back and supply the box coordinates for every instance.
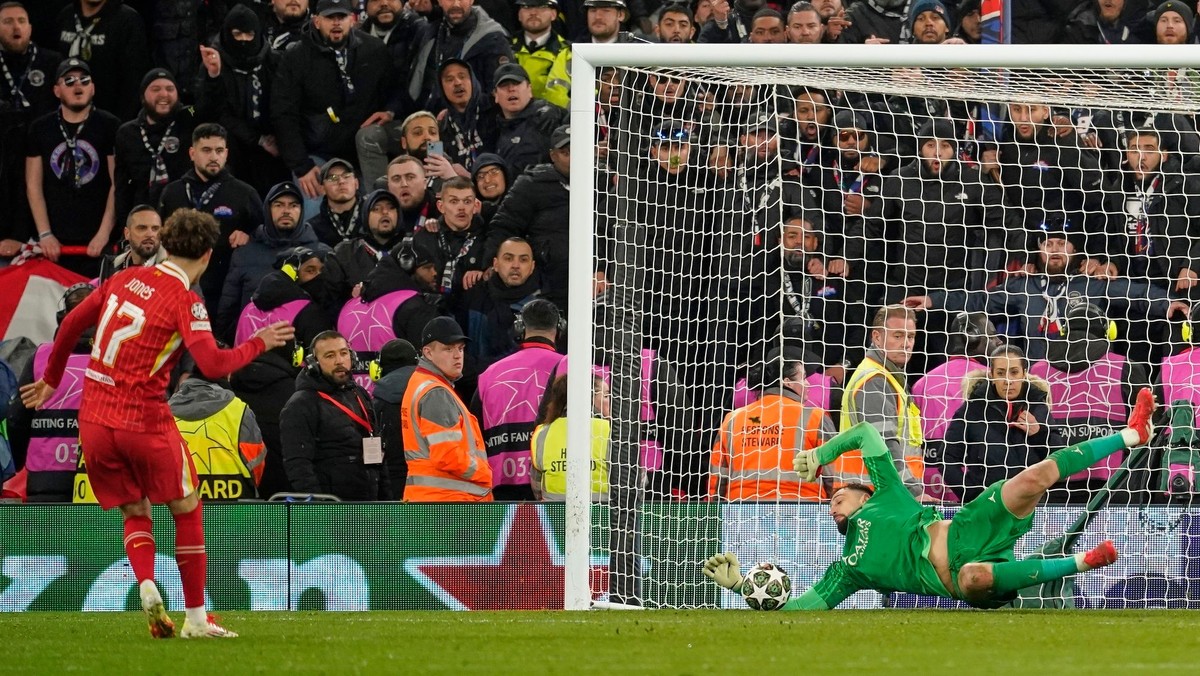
[20,209,294,639]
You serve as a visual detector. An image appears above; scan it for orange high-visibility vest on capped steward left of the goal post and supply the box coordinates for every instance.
[400,366,492,502]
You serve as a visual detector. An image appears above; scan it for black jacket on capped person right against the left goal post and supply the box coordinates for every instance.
[484,163,571,316]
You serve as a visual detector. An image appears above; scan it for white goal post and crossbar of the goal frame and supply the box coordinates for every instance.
[564,43,1200,610]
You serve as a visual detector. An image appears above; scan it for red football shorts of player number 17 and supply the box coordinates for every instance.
[79,420,199,509]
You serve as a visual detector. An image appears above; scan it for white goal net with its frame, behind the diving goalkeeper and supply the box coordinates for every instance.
[566,46,1200,608]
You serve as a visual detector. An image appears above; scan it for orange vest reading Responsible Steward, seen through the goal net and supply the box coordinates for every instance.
[708,394,826,501]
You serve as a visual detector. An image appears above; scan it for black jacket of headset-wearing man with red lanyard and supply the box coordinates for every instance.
[280,367,390,501]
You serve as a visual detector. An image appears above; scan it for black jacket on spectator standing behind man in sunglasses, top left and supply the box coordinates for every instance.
[49,0,150,120]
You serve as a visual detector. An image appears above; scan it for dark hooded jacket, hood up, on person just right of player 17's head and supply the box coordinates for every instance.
[216,183,329,336]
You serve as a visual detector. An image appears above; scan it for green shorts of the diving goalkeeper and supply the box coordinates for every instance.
[946,481,1033,608]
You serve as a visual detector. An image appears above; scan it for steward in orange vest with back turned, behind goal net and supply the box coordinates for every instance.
[708,348,836,501]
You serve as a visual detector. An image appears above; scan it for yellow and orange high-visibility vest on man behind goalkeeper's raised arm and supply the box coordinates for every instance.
[830,357,925,487]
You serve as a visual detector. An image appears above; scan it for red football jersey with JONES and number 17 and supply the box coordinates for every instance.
[44,262,265,432]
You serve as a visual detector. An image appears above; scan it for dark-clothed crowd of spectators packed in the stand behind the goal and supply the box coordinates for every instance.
[0,0,1200,497]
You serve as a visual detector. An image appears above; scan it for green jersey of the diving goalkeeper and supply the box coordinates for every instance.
[784,423,950,610]
